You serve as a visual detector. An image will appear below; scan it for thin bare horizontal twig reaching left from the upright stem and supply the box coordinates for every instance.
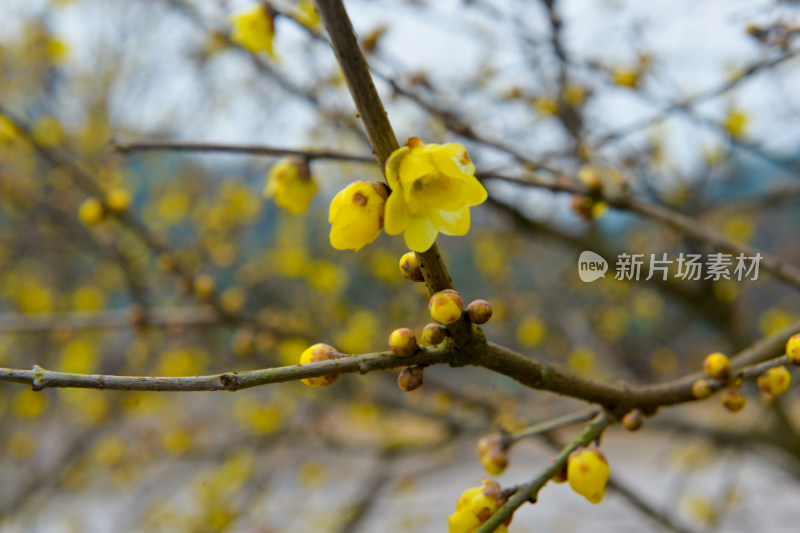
[111,141,375,164]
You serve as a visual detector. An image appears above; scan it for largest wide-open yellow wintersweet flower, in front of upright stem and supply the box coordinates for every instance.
[385,137,487,252]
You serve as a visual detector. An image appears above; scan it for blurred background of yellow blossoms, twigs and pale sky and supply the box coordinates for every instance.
[0,0,800,533]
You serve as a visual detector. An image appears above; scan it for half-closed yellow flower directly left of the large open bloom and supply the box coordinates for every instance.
[328,181,387,252]
